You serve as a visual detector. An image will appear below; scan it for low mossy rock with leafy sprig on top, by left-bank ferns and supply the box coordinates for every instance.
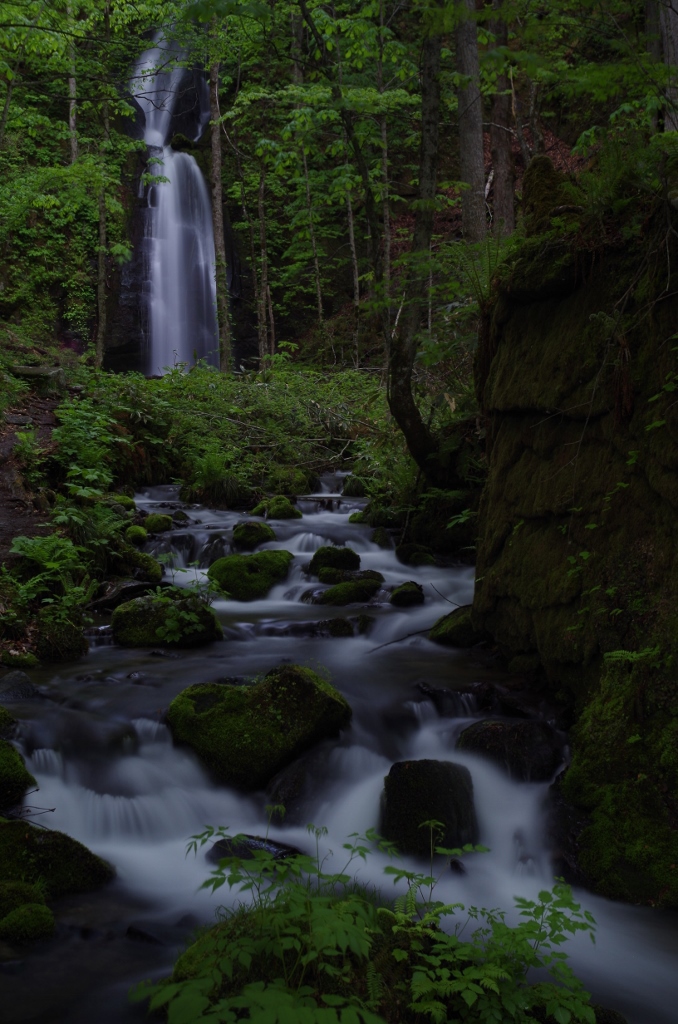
[111,588,223,647]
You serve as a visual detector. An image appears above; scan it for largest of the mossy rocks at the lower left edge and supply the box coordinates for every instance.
[0,820,116,899]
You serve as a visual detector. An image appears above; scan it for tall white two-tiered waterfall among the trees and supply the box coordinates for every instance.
[130,39,218,374]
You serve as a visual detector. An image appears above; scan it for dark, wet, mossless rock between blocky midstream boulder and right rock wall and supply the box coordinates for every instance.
[457,719,563,782]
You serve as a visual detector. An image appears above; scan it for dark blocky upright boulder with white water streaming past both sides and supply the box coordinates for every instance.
[380,759,478,857]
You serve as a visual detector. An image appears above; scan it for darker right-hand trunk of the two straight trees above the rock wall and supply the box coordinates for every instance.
[490,0,515,238]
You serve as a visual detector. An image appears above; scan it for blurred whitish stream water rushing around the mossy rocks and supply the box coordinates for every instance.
[0,479,678,1024]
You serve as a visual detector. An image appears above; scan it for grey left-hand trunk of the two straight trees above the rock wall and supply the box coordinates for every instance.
[455,0,486,242]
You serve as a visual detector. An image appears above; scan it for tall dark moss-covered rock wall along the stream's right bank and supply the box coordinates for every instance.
[473,205,678,906]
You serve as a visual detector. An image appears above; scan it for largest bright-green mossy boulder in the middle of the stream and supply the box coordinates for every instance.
[167,665,351,790]
